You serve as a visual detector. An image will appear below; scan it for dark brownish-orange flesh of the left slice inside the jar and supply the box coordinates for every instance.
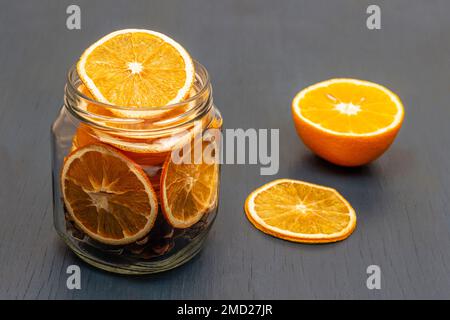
[63,146,156,240]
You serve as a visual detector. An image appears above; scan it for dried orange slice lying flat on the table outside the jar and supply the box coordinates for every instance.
[245,179,356,243]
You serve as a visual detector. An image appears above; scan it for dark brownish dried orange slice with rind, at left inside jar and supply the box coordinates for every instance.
[61,144,158,245]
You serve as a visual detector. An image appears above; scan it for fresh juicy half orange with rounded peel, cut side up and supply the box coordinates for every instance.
[292,79,404,166]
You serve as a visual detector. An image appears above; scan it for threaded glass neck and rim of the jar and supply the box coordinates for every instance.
[64,60,213,136]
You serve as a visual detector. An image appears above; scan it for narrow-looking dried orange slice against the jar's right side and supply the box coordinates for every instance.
[160,142,219,228]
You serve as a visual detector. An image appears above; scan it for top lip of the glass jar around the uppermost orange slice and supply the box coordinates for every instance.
[67,59,211,112]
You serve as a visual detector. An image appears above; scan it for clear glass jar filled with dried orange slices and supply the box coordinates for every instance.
[52,62,222,274]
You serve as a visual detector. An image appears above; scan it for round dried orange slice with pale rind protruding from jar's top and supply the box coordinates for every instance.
[77,29,195,117]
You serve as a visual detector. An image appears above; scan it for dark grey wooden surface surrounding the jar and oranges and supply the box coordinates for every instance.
[0,0,450,299]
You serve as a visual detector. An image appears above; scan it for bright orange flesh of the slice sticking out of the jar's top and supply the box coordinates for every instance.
[85,32,186,107]
